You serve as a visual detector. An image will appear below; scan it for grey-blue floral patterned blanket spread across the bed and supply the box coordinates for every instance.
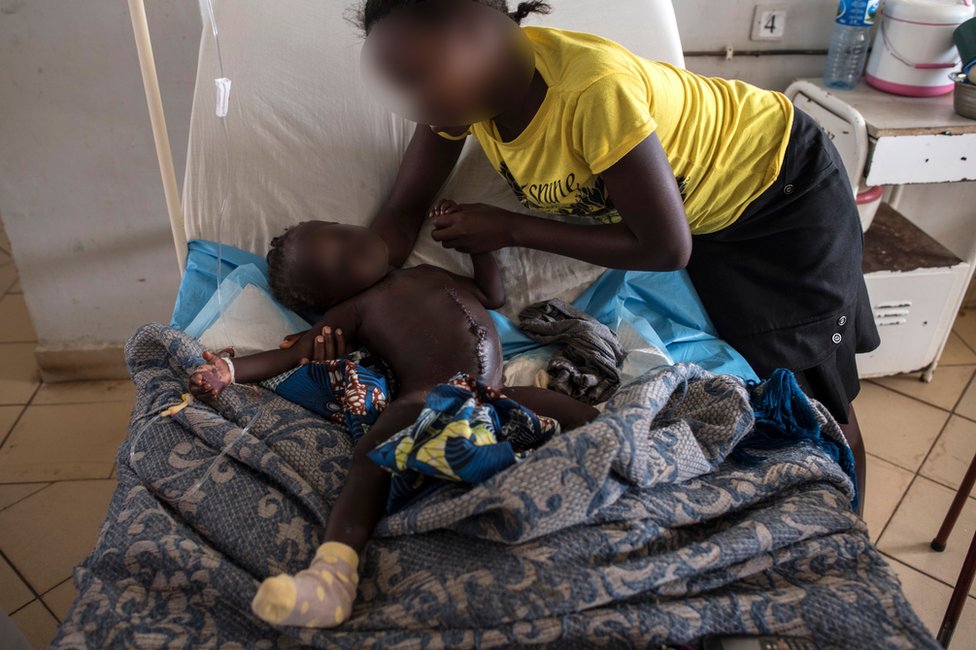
[54,325,938,649]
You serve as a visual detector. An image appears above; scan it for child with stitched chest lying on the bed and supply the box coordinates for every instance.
[183,203,597,627]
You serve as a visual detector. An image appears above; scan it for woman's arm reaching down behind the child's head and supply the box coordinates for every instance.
[371,124,464,267]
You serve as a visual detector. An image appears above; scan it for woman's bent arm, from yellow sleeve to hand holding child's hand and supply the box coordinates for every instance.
[433,134,691,271]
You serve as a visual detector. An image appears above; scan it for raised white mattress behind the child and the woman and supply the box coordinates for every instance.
[183,0,683,314]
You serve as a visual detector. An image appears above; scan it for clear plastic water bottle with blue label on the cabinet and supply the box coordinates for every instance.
[824,0,880,90]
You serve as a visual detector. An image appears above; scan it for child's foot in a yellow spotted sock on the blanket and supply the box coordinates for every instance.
[251,542,359,628]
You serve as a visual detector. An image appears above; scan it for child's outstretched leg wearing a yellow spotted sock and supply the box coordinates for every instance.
[251,395,424,628]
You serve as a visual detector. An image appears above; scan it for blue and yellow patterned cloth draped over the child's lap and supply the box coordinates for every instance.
[369,373,559,513]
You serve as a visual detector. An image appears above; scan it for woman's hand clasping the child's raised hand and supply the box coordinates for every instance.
[430,201,518,255]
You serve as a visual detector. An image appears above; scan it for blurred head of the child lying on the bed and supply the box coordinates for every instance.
[268,221,390,311]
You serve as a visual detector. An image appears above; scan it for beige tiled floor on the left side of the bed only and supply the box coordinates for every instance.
[0,231,134,648]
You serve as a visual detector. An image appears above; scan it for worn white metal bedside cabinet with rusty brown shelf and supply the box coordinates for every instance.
[787,80,976,380]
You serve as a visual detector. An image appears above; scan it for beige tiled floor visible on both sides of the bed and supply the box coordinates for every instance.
[0,220,976,648]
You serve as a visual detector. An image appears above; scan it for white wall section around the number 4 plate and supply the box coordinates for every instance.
[673,0,839,90]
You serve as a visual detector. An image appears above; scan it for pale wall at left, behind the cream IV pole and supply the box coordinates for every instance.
[0,0,200,376]
